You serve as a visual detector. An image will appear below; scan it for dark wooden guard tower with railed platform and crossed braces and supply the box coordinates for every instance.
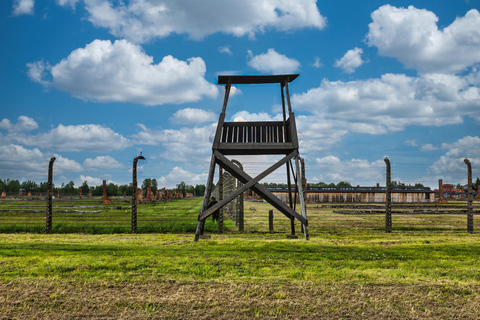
[195,74,308,241]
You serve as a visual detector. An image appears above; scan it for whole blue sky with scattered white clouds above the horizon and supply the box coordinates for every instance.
[0,0,480,188]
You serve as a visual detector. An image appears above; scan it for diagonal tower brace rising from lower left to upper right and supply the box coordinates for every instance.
[198,150,297,220]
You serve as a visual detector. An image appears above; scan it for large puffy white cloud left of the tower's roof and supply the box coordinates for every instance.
[27,40,218,106]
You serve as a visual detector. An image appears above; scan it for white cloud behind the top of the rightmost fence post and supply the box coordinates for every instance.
[428,136,480,183]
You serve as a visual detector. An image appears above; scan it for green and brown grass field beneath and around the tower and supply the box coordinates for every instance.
[0,199,480,319]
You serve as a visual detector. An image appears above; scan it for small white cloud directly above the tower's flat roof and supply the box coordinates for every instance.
[248,48,300,74]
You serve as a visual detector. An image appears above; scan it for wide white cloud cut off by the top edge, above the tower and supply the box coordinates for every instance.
[85,0,326,42]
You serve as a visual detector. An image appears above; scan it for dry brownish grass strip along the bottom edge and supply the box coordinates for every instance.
[0,280,480,319]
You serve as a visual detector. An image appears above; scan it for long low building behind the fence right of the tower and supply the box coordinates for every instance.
[267,186,435,203]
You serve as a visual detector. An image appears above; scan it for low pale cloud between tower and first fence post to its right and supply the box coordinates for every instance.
[316,155,385,186]
